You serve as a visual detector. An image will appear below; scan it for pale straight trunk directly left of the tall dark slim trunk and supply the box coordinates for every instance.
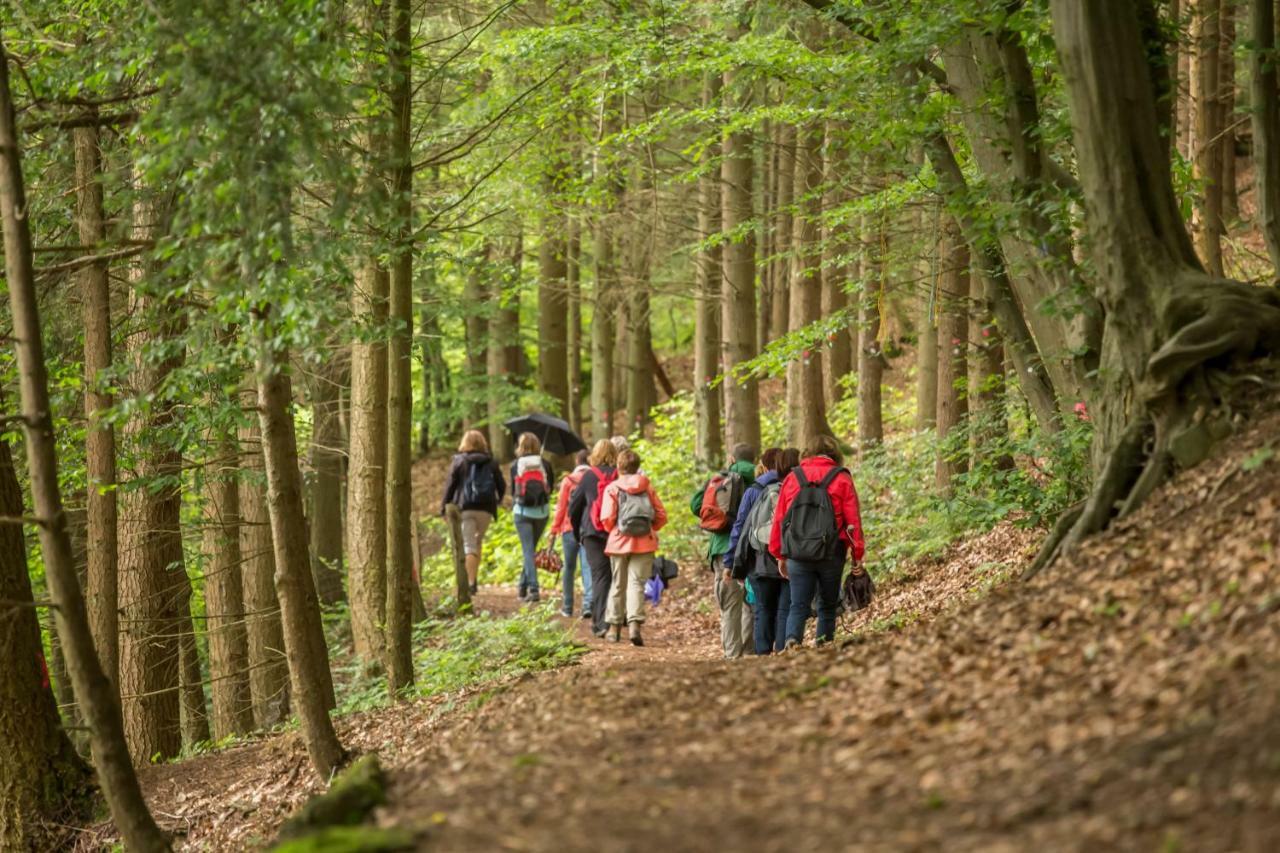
[347,259,390,669]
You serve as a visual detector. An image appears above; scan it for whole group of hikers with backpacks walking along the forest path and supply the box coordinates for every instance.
[442,430,865,658]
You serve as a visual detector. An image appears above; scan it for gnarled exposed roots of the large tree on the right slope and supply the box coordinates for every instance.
[1023,274,1280,580]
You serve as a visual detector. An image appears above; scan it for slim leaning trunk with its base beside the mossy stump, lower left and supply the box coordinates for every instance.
[257,348,346,781]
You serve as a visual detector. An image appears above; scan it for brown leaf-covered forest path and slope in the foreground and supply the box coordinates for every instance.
[102,399,1280,852]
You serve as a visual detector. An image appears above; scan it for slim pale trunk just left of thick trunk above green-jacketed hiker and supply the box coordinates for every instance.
[694,74,727,467]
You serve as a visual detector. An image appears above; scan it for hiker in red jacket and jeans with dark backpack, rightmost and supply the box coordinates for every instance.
[769,435,864,648]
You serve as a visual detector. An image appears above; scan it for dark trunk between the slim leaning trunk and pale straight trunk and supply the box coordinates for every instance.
[308,365,345,605]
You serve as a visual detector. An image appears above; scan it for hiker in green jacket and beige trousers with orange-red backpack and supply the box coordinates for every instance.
[689,443,755,660]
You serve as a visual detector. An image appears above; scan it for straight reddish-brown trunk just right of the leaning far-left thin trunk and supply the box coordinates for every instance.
[72,124,120,684]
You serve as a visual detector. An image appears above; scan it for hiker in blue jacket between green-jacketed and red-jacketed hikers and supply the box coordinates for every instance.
[724,447,800,654]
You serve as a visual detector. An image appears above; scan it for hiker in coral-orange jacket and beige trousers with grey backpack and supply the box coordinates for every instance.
[600,450,667,646]
